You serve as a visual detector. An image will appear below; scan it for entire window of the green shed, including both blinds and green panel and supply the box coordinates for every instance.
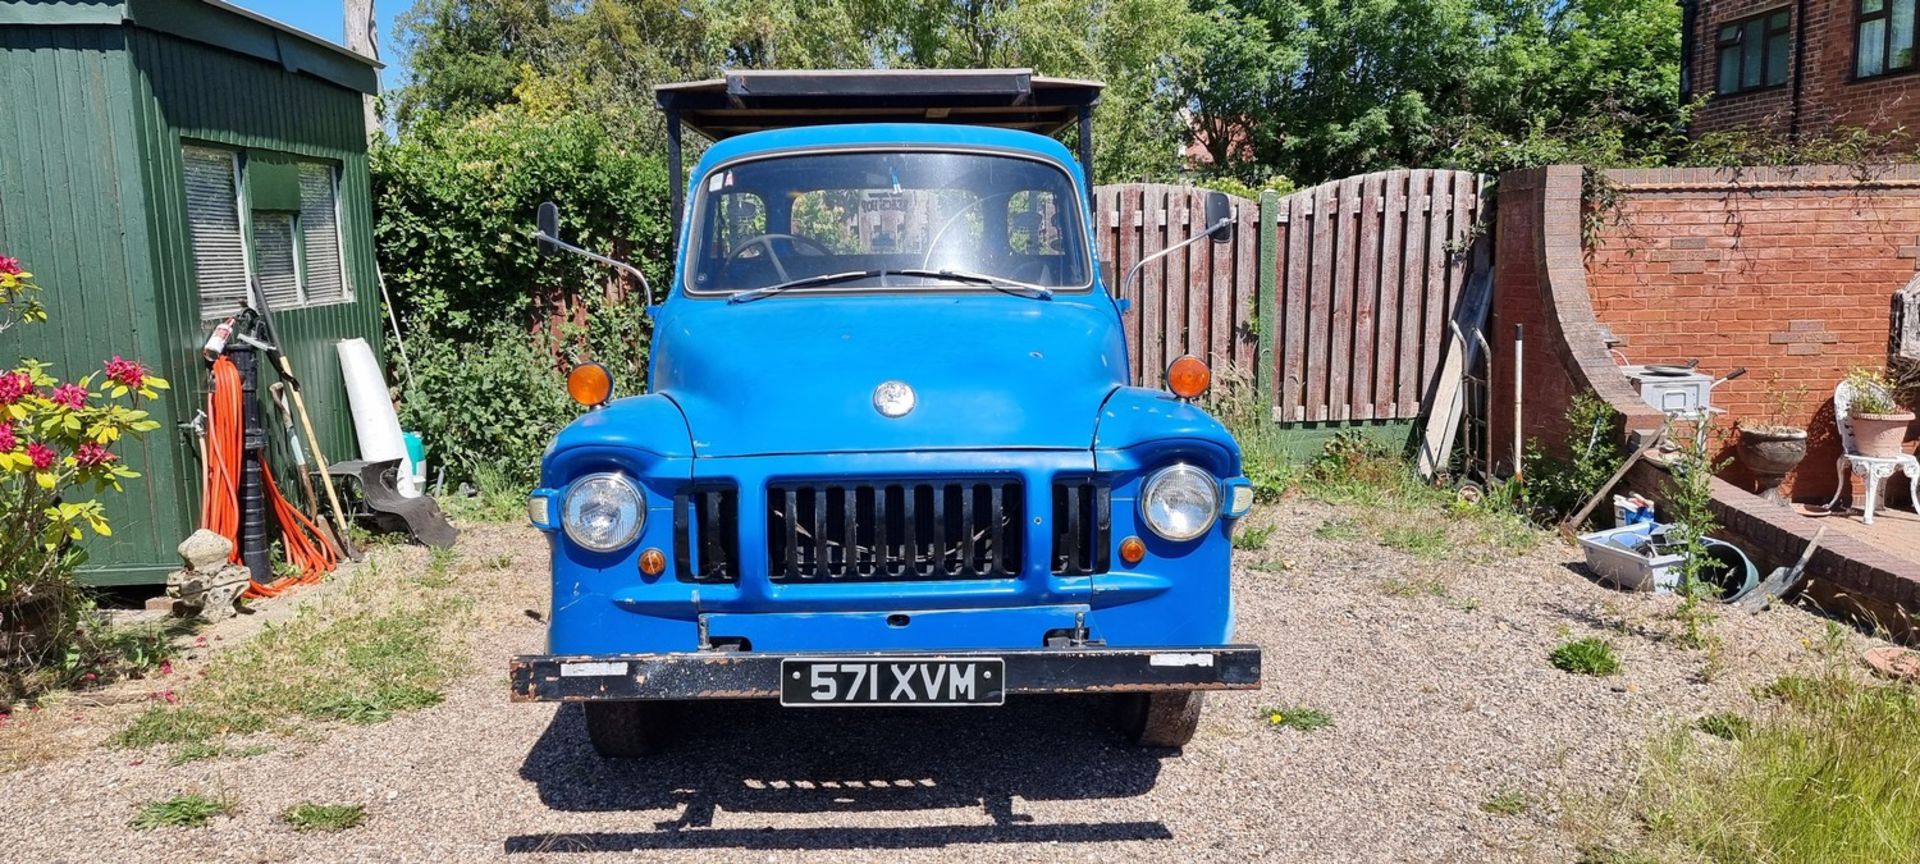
[180,146,353,319]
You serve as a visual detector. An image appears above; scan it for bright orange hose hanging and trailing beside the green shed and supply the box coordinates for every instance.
[200,357,340,597]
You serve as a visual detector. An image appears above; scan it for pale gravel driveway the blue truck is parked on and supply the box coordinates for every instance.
[0,501,1859,862]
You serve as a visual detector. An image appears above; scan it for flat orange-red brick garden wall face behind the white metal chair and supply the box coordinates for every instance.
[1586,167,1920,501]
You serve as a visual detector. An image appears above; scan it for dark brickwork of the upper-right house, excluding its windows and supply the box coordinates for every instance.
[1690,0,1920,134]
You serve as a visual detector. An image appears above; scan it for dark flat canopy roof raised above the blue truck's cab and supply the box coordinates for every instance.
[653,69,1102,140]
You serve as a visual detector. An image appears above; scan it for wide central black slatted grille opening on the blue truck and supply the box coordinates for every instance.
[766,478,1025,582]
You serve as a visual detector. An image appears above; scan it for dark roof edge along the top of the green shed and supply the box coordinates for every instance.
[0,0,382,94]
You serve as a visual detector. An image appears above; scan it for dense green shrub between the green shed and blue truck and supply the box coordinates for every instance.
[372,106,672,484]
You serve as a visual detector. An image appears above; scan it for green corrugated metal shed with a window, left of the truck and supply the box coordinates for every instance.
[0,0,382,586]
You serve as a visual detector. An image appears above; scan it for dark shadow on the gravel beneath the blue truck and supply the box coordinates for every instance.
[505,697,1175,852]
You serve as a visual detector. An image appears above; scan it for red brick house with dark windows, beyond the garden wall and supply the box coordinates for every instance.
[1680,0,1920,134]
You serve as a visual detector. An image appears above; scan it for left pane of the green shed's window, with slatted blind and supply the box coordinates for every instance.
[180,148,250,319]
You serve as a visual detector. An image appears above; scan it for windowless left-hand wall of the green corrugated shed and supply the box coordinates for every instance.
[0,27,182,582]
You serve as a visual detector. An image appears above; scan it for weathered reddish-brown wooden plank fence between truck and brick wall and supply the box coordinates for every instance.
[1094,171,1480,422]
